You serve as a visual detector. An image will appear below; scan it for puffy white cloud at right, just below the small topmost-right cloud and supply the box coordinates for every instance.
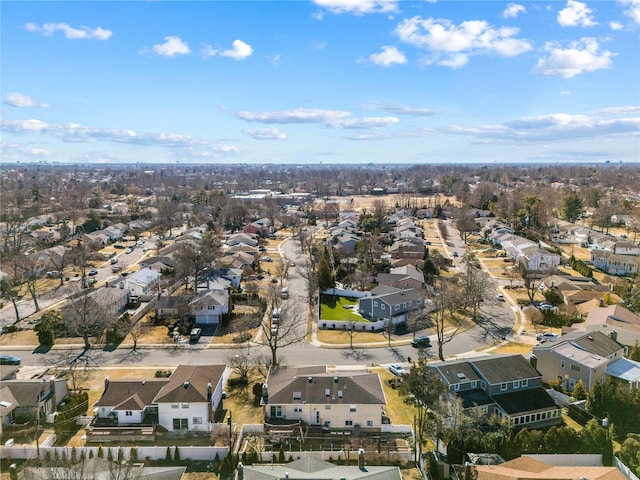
[535,37,617,78]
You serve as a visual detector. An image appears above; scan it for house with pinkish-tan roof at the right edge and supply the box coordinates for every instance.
[569,305,640,347]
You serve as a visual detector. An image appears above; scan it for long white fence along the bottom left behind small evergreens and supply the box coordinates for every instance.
[0,444,229,461]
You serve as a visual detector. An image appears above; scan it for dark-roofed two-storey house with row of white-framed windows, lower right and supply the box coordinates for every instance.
[431,355,562,428]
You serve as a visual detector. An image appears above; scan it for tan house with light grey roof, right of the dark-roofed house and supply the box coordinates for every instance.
[532,331,625,390]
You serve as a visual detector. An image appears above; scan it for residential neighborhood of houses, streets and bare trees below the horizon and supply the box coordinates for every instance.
[0,162,640,479]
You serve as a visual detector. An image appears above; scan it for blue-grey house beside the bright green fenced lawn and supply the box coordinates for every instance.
[358,285,425,325]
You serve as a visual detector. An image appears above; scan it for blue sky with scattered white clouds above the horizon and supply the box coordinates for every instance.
[0,0,640,164]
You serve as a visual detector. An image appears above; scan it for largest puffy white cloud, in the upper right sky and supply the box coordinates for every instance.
[395,16,532,68]
